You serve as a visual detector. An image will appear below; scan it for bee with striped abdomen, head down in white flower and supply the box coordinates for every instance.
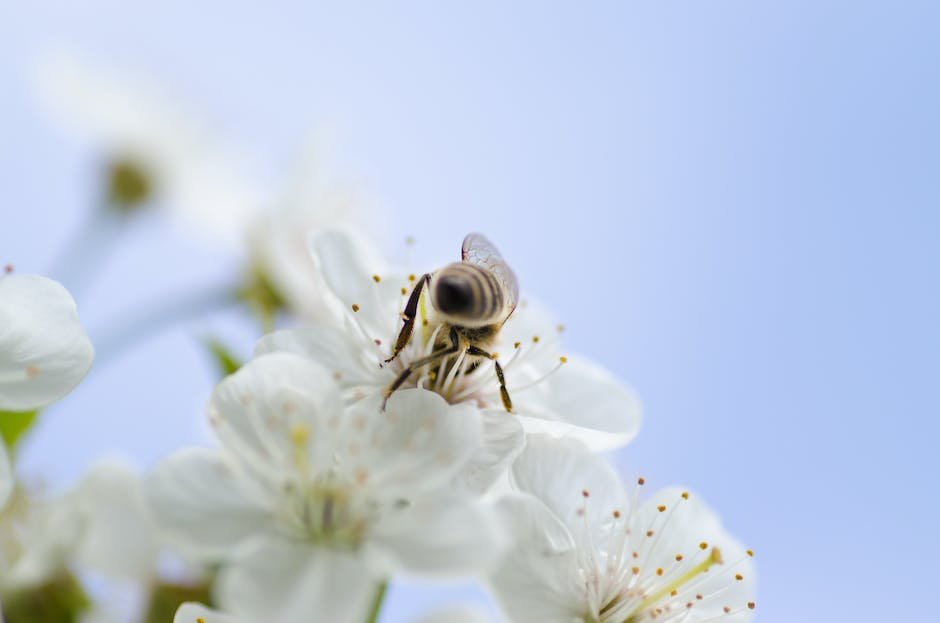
[383,234,519,412]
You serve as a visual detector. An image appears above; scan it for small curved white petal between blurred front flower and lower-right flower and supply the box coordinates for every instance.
[458,409,525,493]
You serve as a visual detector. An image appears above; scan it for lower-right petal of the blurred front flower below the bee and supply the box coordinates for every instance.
[370,495,505,577]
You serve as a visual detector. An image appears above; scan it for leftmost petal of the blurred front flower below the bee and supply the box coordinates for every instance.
[147,448,273,560]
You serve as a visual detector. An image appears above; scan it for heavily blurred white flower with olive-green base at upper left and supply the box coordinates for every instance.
[37,54,260,244]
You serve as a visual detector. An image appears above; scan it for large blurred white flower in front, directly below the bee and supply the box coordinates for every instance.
[151,353,500,622]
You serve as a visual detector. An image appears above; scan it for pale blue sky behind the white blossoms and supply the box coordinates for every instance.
[0,0,940,623]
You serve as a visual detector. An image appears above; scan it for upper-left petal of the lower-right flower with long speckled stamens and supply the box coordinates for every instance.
[512,435,629,540]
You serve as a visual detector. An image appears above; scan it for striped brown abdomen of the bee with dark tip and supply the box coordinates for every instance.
[430,262,506,327]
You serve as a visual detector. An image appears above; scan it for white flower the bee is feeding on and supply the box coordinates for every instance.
[255,230,640,464]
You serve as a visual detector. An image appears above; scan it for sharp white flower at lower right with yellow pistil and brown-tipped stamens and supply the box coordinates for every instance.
[491,436,754,623]
